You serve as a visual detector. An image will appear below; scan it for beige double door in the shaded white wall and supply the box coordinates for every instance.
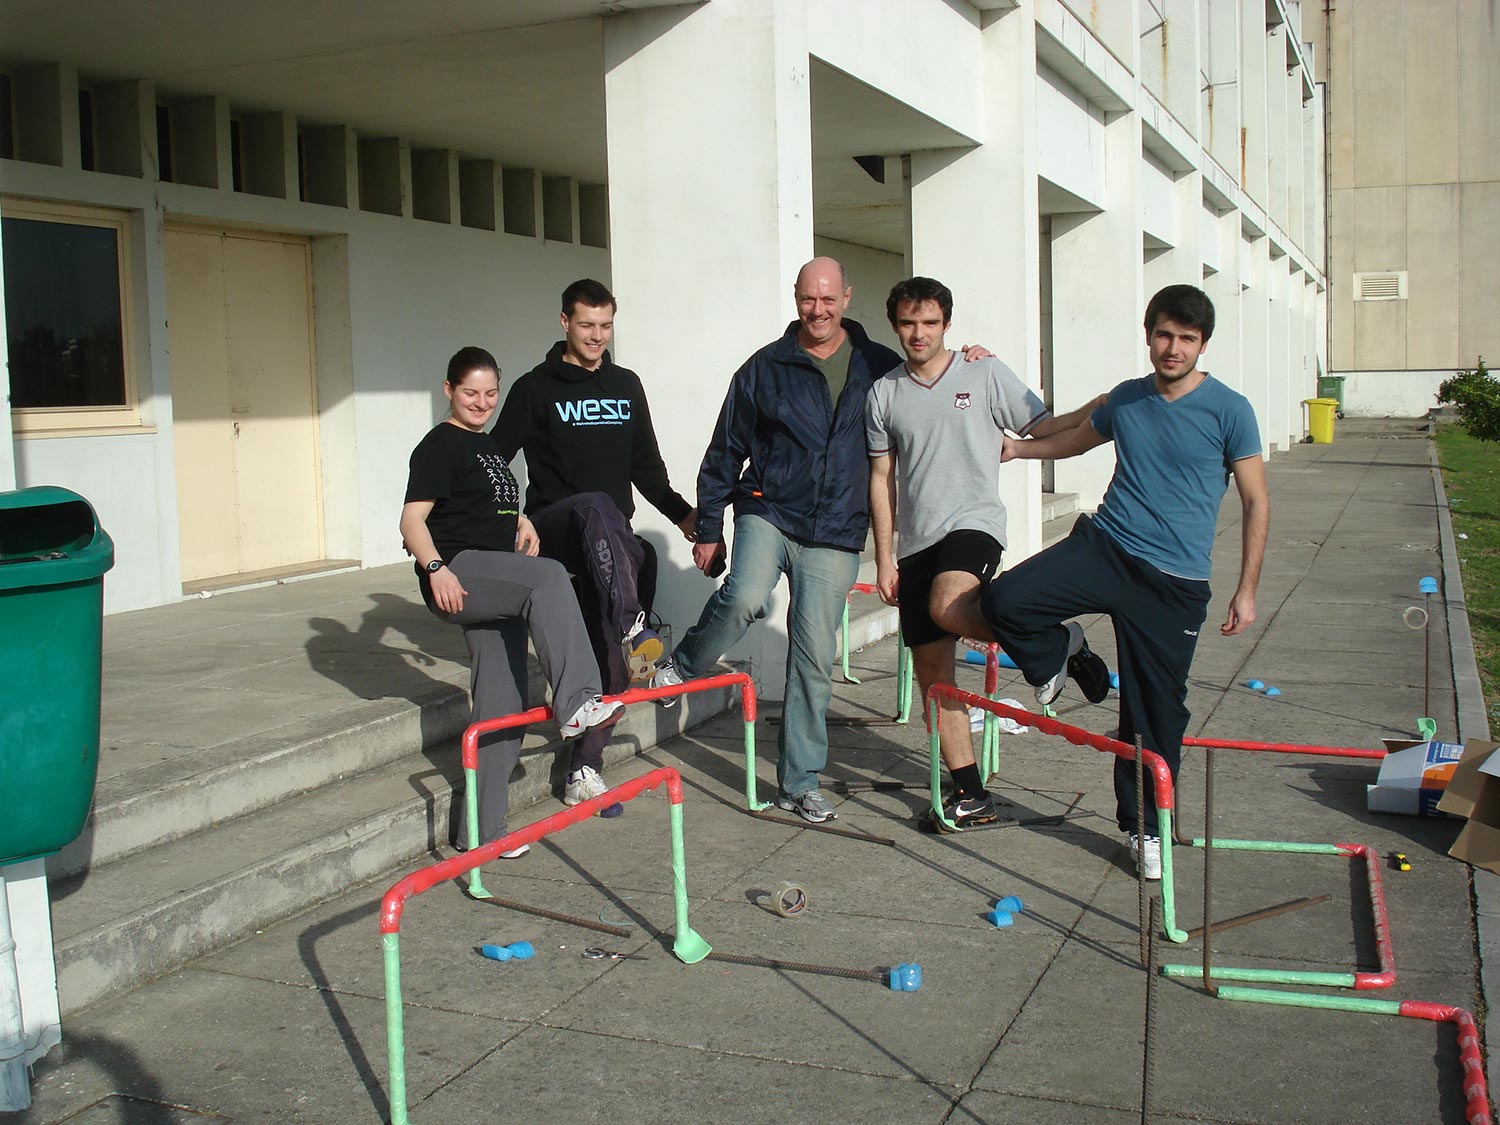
[167,228,323,582]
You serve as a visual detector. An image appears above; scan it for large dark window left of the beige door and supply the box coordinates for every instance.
[0,218,128,410]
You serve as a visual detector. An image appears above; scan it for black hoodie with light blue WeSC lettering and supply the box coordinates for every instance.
[494,341,693,524]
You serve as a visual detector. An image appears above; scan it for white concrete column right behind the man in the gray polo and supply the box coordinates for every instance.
[911,0,1044,566]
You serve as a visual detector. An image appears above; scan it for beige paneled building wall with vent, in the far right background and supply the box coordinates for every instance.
[1304,0,1500,417]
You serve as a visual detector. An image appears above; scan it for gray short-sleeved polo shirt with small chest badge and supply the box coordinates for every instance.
[864,351,1049,558]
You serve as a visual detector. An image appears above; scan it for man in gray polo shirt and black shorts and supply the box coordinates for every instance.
[866,278,1109,831]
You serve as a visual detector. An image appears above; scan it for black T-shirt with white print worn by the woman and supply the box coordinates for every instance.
[405,422,521,593]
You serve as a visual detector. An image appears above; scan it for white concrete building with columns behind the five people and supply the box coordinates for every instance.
[0,0,1338,636]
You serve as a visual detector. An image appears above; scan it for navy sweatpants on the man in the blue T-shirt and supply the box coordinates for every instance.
[980,516,1209,836]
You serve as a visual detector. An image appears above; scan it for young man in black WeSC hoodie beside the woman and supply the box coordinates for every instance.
[494,279,698,804]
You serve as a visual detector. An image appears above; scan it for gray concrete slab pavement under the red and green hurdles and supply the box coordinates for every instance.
[8,422,1500,1125]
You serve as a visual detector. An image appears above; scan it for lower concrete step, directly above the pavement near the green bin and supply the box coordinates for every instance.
[51,690,738,1014]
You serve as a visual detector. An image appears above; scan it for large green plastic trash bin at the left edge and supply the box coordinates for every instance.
[0,488,114,866]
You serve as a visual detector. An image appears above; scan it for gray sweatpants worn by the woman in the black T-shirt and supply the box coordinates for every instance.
[432,551,600,843]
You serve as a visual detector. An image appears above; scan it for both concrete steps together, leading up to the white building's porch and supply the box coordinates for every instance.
[48,603,896,1014]
